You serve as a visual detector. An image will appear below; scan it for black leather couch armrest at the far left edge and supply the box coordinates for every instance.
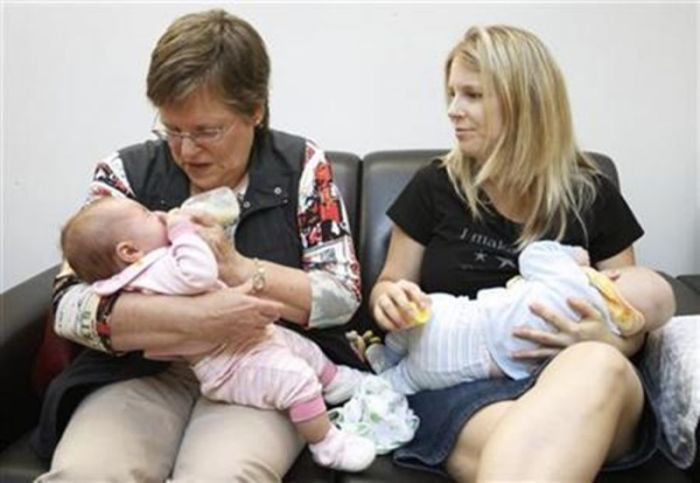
[0,265,59,448]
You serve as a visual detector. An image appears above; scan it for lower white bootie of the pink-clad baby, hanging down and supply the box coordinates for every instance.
[309,425,377,471]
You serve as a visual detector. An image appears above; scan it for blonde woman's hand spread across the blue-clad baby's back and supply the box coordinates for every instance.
[513,298,643,359]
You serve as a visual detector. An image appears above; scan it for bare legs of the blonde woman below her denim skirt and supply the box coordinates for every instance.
[447,343,644,481]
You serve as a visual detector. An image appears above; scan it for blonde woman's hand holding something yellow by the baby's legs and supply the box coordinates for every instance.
[372,280,430,331]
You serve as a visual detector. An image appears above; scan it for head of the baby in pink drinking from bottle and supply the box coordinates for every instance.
[61,196,169,283]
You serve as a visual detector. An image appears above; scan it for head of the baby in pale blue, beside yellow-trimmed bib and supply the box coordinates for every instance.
[603,266,676,327]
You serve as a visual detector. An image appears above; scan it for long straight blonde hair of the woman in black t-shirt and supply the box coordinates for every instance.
[443,25,597,248]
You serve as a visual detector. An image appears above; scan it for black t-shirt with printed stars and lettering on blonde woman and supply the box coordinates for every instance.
[387,160,644,297]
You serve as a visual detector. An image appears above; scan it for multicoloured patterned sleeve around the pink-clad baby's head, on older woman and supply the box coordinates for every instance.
[53,154,133,353]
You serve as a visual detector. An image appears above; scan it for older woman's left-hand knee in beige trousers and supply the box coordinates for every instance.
[38,377,192,482]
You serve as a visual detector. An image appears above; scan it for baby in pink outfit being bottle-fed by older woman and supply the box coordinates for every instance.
[61,197,375,471]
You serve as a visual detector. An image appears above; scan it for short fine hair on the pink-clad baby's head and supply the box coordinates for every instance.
[61,196,130,283]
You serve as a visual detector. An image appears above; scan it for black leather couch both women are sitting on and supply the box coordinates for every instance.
[0,150,700,483]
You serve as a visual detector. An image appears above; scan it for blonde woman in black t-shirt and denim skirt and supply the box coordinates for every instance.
[370,26,673,481]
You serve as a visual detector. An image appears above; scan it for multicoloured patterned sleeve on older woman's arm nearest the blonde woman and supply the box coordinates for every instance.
[298,141,362,328]
